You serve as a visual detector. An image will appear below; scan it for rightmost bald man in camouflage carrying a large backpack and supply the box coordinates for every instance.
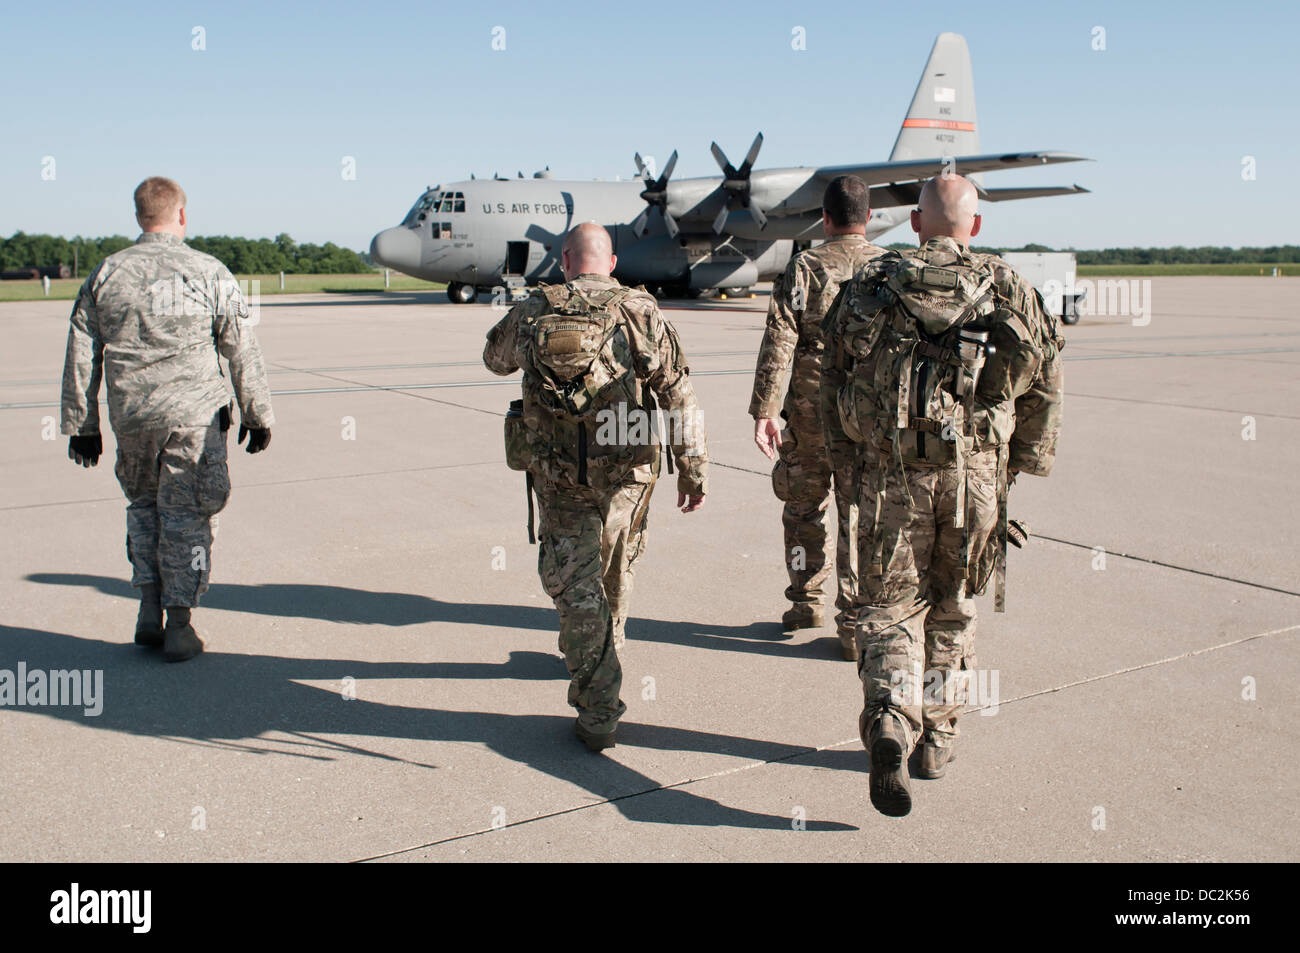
[823,174,1065,816]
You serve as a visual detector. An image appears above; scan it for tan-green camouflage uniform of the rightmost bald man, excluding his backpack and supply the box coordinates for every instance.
[822,238,1065,749]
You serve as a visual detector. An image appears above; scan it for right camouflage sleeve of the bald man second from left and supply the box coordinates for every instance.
[624,295,709,497]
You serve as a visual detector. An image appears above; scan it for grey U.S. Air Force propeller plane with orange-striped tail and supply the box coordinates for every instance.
[371,33,1088,304]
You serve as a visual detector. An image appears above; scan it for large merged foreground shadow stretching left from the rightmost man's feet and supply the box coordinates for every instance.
[0,608,862,831]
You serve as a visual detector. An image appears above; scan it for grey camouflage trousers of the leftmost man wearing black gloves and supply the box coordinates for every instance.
[114,417,230,607]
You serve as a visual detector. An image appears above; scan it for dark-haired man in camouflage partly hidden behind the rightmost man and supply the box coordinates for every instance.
[749,176,884,660]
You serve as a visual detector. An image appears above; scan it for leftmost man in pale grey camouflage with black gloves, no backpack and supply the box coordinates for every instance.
[62,177,274,662]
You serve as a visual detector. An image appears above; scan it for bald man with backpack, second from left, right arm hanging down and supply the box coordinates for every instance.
[484,222,707,751]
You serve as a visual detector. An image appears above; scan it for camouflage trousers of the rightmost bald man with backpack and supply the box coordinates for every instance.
[857,454,997,746]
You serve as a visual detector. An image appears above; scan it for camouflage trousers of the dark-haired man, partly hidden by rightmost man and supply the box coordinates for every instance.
[772,417,858,641]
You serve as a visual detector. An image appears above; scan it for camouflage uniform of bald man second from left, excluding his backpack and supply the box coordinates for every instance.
[484,274,707,733]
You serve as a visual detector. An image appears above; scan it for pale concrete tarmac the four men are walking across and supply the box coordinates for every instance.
[0,278,1300,861]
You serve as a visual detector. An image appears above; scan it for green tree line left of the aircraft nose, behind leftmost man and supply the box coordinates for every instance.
[0,231,371,277]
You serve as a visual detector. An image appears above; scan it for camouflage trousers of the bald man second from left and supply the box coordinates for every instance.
[534,480,654,732]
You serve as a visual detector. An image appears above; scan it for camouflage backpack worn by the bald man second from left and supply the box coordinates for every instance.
[506,283,658,525]
